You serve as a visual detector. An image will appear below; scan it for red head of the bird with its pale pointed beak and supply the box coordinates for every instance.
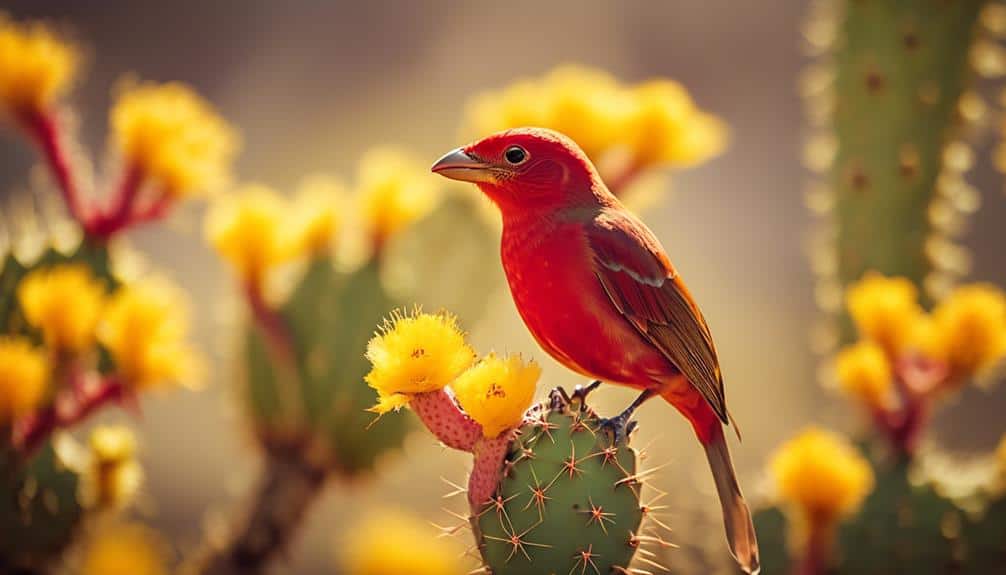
[433,128,610,216]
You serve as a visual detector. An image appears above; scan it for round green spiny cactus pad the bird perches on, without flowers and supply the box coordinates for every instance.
[472,390,646,575]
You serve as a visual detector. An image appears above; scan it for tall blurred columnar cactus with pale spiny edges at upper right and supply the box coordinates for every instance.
[803,0,999,341]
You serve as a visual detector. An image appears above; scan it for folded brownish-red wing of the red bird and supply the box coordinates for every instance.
[585,211,728,423]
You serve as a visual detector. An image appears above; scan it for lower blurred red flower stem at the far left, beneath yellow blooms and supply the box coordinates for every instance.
[13,374,127,458]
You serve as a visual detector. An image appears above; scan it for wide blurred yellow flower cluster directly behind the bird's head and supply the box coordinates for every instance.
[465,65,727,167]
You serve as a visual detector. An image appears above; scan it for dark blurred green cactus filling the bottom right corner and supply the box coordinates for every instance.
[755,448,1006,575]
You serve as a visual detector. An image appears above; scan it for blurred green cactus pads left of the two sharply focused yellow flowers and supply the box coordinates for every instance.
[244,257,411,475]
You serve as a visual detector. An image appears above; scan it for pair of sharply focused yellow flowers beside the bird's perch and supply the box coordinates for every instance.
[366,311,541,438]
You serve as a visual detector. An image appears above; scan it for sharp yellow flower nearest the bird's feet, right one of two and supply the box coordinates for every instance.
[451,354,541,438]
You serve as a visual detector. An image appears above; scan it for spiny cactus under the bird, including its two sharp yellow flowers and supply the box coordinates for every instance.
[367,314,664,575]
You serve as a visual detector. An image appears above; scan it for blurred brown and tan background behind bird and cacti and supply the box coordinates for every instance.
[0,0,1006,574]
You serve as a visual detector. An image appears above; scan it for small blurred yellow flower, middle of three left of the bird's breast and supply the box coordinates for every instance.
[286,175,345,256]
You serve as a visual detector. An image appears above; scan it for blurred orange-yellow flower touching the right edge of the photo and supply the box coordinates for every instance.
[933,283,1006,376]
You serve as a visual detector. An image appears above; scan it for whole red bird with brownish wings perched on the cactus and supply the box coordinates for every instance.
[433,128,759,573]
